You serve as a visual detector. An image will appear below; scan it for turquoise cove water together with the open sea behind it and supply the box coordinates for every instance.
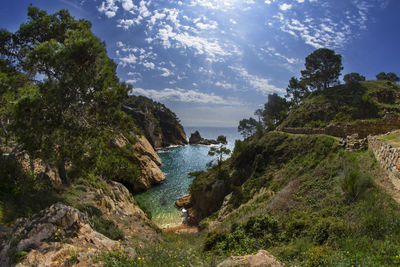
[135,127,240,227]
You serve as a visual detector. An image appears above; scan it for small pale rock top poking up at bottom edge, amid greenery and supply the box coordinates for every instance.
[218,250,285,267]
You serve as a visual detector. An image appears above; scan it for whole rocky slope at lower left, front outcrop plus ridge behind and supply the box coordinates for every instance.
[0,182,159,266]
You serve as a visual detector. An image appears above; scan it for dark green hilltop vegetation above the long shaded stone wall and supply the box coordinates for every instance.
[281,80,400,127]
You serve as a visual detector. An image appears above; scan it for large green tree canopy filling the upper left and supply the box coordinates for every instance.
[0,6,134,182]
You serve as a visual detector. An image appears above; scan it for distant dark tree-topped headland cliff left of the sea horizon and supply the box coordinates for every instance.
[123,96,187,148]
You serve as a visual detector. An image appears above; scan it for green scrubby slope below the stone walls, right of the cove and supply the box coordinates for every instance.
[191,132,400,266]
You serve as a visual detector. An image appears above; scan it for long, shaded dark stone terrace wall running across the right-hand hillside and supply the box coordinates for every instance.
[277,113,400,138]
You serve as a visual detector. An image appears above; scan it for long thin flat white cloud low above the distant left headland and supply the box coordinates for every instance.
[131,88,238,105]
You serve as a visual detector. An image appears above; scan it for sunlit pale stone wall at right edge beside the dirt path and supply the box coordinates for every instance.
[368,136,400,190]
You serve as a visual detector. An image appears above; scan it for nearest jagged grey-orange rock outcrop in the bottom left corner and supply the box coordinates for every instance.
[0,203,119,266]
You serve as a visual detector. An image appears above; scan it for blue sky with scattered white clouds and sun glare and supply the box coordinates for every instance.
[0,0,400,127]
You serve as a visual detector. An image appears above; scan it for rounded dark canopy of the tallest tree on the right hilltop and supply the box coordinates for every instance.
[301,48,343,90]
